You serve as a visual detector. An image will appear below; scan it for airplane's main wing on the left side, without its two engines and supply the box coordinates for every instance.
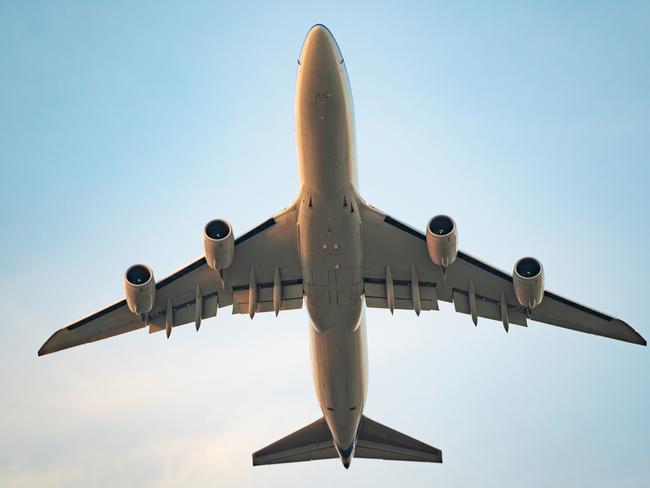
[38,205,303,356]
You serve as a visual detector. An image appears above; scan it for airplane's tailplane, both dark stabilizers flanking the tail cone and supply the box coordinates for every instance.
[253,416,442,468]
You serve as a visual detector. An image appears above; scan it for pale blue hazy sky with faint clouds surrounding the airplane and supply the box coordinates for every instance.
[0,1,650,488]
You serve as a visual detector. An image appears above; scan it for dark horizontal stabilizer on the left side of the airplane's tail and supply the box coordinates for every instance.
[253,418,339,466]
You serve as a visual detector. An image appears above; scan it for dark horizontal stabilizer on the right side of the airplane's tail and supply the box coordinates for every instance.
[354,415,442,463]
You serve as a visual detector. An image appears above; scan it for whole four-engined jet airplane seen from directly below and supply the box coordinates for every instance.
[38,24,646,469]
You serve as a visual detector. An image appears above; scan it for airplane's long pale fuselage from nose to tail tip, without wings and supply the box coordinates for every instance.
[295,25,367,465]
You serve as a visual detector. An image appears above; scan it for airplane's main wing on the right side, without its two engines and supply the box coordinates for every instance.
[360,204,646,346]
